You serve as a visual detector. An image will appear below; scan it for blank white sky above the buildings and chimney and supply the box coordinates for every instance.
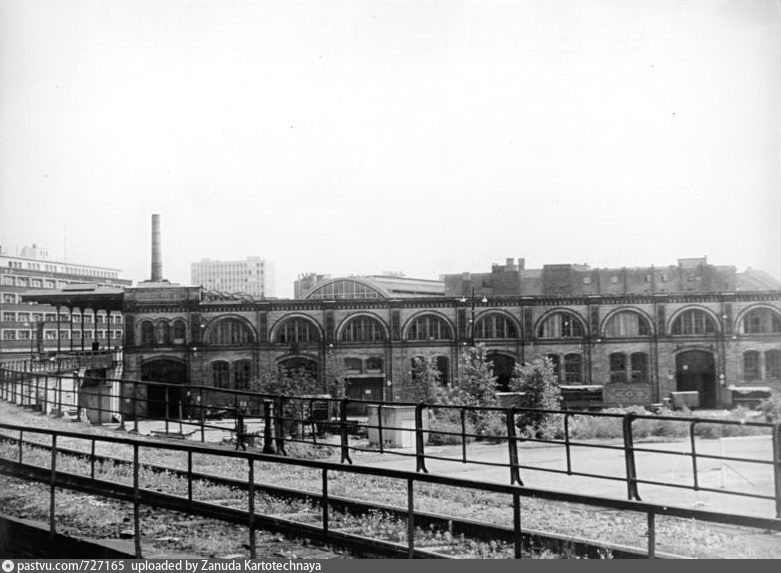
[0,0,781,296]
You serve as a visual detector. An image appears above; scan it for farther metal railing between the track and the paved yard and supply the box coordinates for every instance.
[0,365,781,517]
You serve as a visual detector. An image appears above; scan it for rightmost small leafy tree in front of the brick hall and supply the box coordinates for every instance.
[510,358,562,438]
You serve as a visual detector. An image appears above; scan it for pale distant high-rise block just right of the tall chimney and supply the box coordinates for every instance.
[190,257,275,298]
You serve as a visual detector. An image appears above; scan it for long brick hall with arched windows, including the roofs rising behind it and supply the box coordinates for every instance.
[28,258,781,408]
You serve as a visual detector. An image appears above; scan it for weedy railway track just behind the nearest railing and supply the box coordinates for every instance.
[0,433,680,559]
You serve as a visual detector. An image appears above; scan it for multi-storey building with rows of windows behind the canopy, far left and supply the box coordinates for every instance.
[0,245,133,358]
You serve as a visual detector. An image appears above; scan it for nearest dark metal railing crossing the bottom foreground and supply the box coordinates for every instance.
[0,423,781,558]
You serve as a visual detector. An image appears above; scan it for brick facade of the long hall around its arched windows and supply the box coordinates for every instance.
[120,286,781,412]
